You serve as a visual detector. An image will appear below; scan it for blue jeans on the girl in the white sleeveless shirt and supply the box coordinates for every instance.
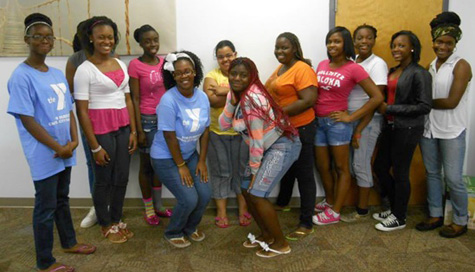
[420,130,468,226]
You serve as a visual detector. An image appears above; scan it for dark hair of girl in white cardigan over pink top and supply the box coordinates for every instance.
[79,16,120,55]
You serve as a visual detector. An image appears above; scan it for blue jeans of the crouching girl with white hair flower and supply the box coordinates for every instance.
[152,151,211,238]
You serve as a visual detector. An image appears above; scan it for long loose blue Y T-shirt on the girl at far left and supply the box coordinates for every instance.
[7,63,76,181]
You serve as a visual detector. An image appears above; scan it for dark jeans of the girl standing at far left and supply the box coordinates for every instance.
[33,167,77,269]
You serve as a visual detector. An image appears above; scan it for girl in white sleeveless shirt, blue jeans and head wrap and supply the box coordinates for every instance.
[416,12,472,238]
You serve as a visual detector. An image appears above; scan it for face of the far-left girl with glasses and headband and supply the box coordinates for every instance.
[25,24,54,56]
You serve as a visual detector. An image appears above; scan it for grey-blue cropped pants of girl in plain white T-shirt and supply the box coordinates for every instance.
[350,115,383,188]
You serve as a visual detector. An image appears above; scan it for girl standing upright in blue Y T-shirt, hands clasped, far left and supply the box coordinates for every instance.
[8,13,96,271]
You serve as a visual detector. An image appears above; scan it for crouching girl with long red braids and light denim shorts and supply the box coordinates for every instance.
[219,58,301,258]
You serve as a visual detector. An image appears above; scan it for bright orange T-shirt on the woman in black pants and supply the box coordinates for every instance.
[266,61,318,128]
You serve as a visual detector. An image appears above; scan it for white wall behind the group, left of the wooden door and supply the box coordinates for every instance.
[0,0,329,198]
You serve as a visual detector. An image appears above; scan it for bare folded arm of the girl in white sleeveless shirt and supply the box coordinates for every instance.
[432,59,472,110]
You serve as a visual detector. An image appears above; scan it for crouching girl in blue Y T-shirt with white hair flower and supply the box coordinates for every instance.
[150,51,211,248]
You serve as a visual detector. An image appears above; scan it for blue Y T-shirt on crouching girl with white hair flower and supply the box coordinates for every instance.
[150,87,210,160]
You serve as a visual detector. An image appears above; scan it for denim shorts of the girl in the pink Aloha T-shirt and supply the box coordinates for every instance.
[314,117,353,146]
